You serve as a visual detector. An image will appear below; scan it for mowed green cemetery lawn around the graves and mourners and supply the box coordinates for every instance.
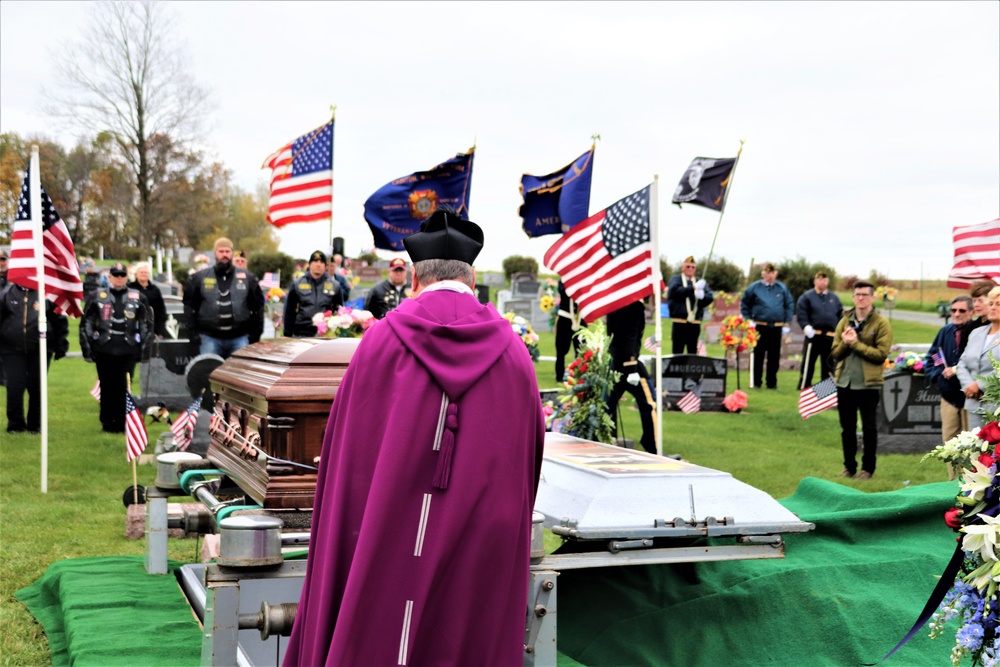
[0,320,947,665]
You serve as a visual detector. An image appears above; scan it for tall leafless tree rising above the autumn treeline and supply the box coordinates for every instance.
[50,0,207,250]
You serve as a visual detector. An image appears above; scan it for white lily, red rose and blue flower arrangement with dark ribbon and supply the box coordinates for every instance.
[924,356,1000,665]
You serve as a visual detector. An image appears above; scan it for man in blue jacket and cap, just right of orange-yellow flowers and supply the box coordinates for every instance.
[740,262,795,389]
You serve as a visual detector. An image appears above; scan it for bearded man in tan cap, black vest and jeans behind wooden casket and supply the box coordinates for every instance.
[184,238,264,359]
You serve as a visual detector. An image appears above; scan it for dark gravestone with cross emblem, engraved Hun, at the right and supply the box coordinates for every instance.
[872,371,941,453]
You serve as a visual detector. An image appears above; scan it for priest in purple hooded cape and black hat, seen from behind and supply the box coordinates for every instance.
[284,211,545,666]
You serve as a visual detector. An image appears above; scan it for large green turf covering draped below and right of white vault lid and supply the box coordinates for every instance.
[558,478,958,667]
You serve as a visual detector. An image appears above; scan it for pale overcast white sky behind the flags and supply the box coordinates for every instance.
[0,0,1000,279]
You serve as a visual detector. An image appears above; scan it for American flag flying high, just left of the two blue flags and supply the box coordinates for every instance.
[261,119,333,227]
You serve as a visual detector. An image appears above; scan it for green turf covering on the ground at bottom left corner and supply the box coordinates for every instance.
[15,556,201,667]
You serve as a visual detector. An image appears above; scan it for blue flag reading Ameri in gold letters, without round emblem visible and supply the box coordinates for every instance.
[518,146,594,238]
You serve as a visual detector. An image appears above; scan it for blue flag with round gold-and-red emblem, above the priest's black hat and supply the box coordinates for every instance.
[365,147,475,252]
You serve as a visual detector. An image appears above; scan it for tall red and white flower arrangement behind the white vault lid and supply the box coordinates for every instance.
[551,321,620,444]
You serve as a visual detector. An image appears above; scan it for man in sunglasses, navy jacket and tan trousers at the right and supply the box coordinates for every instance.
[924,296,973,462]
